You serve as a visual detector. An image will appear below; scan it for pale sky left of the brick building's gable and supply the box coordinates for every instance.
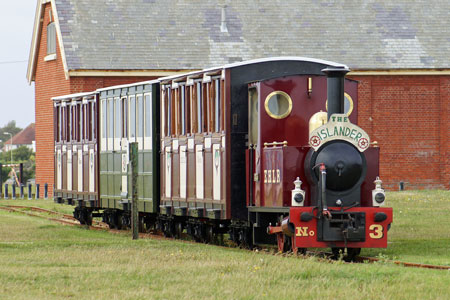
[0,0,37,128]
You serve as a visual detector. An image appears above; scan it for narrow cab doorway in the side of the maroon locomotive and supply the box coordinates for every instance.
[247,84,260,206]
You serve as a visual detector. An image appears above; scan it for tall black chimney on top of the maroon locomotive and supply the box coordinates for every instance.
[322,66,350,120]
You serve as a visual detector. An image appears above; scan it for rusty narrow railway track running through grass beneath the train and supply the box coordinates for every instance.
[0,205,450,270]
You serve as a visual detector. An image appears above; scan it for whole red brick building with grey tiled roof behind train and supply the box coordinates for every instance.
[27,0,450,195]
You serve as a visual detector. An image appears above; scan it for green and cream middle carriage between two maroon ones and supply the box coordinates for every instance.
[97,81,159,228]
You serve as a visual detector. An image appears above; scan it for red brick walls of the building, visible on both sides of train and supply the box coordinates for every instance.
[35,4,450,197]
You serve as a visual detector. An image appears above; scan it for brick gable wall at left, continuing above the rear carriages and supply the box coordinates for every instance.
[35,3,155,197]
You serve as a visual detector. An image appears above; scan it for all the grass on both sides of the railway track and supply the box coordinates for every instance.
[0,191,450,299]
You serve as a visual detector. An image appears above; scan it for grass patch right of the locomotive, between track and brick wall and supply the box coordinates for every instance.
[362,191,450,266]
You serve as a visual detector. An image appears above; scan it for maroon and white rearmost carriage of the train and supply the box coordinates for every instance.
[53,92,99,223]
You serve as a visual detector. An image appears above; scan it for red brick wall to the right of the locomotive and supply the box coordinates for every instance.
[352,76,450,190]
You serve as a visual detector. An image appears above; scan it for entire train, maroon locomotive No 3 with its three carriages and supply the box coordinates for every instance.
[53,57,392,259]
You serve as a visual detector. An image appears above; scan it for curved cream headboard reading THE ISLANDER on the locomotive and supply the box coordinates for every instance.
[309,114,370,152]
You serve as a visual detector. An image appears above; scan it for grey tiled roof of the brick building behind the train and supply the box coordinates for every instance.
[55,0,450,70]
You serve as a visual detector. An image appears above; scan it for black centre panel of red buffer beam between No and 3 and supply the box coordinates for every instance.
[317,211,366,242]
